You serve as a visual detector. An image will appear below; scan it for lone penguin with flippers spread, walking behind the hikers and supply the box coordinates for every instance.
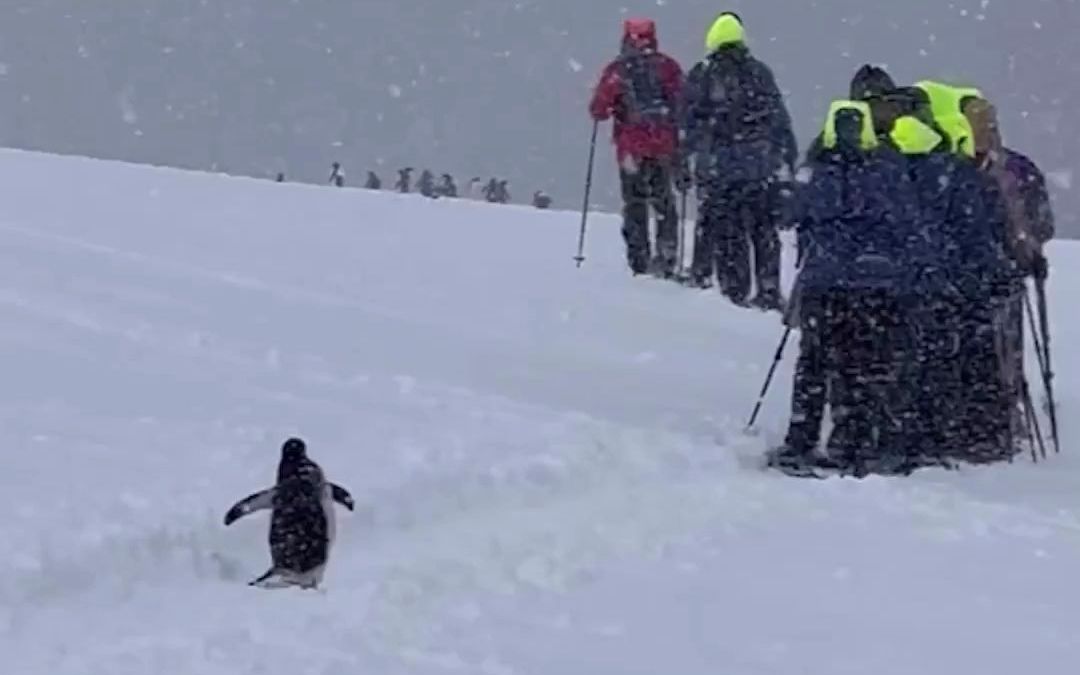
[225,438,355,589]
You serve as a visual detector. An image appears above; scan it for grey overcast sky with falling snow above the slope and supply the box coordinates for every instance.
[0,0,1080,235]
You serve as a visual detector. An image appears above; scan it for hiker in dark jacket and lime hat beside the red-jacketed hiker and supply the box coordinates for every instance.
[681,12,798,310]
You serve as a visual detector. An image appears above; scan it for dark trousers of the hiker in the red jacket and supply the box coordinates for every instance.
[619,159,678,274]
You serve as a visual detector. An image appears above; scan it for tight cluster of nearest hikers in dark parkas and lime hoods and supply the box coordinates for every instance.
[771,71,1054,474]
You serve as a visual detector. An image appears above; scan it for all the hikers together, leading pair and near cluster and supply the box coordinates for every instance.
[590,13,1056,475]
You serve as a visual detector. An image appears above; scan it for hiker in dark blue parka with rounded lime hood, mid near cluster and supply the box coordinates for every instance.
[891,116,1008,461]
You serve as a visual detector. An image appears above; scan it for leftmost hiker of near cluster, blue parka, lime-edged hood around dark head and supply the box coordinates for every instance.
[770,100,918,475]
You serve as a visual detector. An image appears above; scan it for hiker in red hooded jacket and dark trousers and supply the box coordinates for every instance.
[589,18,689,278]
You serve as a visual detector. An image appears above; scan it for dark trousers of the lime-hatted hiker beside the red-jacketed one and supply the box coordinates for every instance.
[691,178,781,305]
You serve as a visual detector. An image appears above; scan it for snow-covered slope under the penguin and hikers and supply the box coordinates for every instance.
[0,152,1080,675]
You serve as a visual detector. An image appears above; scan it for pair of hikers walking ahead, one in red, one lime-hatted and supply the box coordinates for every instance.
[590,12,797,310]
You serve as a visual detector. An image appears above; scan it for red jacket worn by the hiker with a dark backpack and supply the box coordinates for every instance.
[589,52,683,164]
